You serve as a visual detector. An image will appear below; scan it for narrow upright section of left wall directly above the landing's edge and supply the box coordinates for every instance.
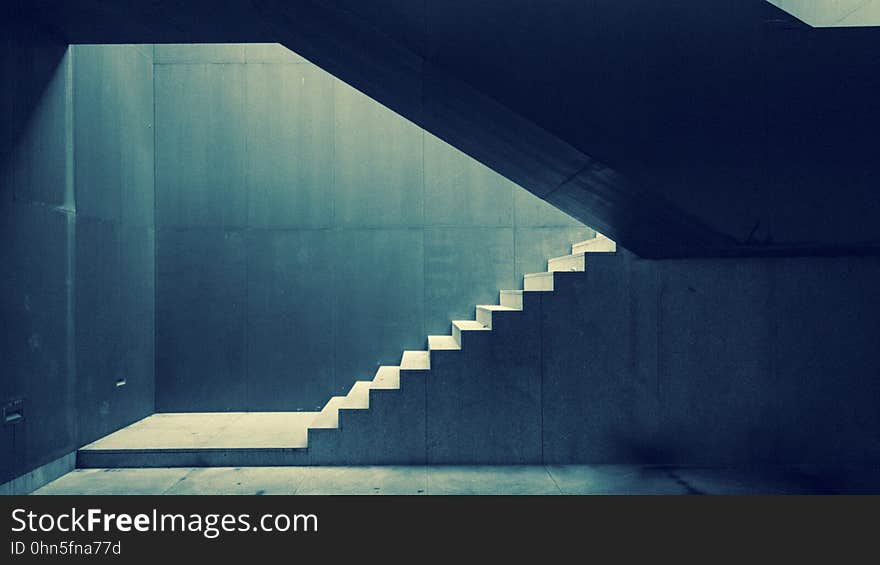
[71,45,155,443]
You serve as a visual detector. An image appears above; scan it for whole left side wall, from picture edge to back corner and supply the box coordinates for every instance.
[0,19,154,482]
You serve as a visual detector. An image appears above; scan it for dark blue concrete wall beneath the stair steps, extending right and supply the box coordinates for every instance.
[264,252,880,466]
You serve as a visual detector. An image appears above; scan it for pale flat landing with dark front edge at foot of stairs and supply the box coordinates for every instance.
[77,412,317,468]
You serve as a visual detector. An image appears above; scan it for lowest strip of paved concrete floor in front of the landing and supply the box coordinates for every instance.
[34,465,880,495]
